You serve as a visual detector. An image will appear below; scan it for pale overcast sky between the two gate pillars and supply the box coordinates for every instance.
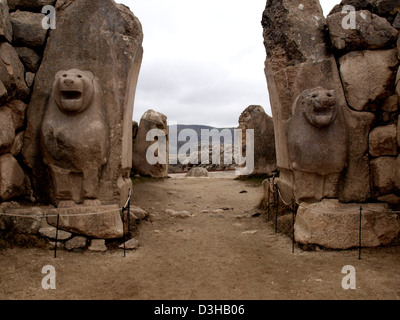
[116,0,340,127]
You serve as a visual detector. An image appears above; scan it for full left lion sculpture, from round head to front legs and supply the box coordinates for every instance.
[41,69,109,204]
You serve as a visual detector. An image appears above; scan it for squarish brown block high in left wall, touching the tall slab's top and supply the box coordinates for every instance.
[10,11,48,48]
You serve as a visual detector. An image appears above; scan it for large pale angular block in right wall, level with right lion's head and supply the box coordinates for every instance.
[339,49,399,111]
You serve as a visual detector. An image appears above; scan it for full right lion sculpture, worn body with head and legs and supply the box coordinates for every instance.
[287,87,348,198]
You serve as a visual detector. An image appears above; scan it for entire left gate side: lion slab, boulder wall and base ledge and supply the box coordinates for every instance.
[0,0,143,249]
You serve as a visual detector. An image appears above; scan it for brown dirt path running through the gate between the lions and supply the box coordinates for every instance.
[0,174,400,300]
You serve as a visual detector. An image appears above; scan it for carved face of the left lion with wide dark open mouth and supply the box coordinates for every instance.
[53,69,94,113]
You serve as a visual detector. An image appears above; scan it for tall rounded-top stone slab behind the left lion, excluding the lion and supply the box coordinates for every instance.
[23,0,143,206]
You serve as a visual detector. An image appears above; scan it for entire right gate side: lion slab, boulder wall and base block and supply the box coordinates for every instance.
[262,0,400,249]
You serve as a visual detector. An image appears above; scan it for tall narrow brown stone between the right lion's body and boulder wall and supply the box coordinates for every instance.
[339,108,376,203]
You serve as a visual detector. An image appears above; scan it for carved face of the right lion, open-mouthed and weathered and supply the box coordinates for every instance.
[302,87,338,128]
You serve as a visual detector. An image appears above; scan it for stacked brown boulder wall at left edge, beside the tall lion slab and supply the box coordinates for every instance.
[0,0,55,202]
